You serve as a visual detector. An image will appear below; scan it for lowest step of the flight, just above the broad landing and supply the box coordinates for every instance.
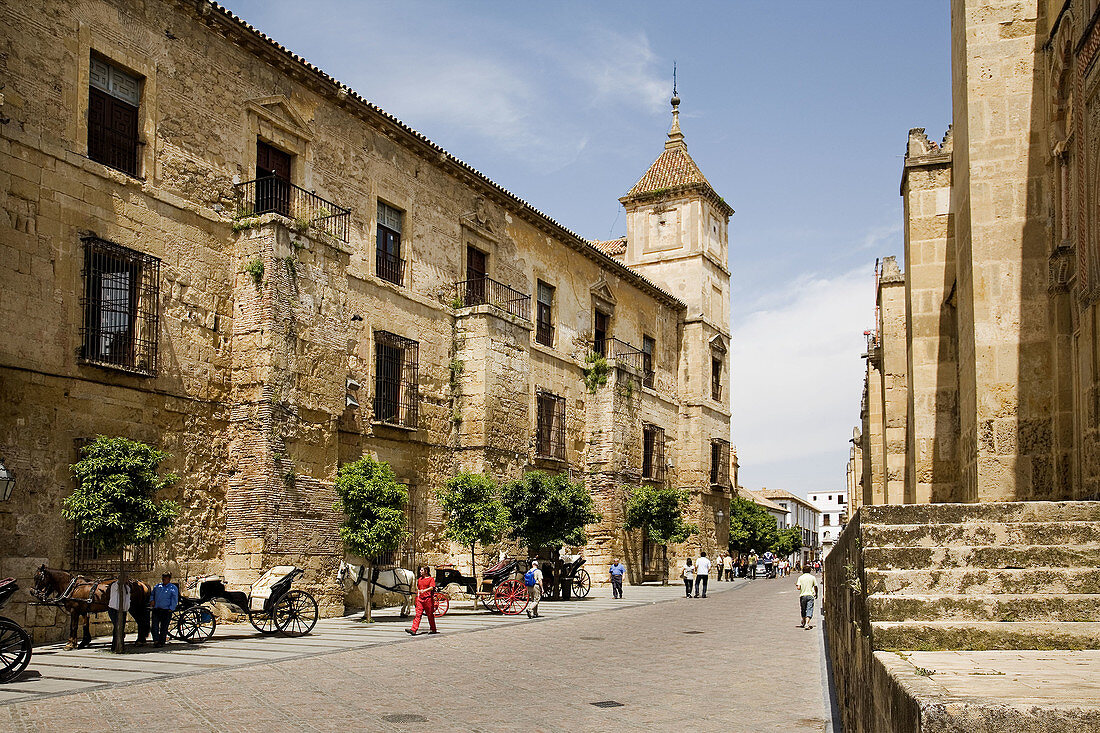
[871,621,1100,652]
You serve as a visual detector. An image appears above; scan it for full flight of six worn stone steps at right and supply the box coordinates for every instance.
[860,502,1100,650]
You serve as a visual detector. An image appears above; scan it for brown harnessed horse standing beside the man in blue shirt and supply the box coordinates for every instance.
[31,565,150,649]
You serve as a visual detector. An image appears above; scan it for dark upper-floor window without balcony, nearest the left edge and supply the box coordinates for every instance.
[88,56,141,176]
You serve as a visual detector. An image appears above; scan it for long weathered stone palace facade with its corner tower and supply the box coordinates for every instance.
[0,0,733,638]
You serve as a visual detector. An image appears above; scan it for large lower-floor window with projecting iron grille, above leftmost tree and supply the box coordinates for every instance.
[80,237,161,376]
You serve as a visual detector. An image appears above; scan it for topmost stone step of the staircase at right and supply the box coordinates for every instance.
[859,502,1100,528]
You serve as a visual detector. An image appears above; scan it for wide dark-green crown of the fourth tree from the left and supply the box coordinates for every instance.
[501,471,603,549]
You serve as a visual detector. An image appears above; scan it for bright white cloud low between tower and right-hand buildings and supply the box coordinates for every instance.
[732,266,875,492]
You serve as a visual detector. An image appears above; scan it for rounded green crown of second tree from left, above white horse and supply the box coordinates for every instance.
[333,456,409,559]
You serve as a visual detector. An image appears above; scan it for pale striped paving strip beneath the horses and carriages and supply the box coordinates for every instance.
[0,581,747,705]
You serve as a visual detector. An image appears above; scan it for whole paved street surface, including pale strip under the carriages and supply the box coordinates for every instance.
[0,579,839,733]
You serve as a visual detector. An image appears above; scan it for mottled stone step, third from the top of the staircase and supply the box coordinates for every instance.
[864,545,1100,570]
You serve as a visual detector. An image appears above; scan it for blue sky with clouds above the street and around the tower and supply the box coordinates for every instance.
[226,0,950,493]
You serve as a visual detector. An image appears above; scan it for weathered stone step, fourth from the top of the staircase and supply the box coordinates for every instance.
[864,568,1100,595]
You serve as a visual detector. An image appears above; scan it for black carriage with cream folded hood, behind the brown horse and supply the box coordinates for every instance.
[171,565,318,642]
